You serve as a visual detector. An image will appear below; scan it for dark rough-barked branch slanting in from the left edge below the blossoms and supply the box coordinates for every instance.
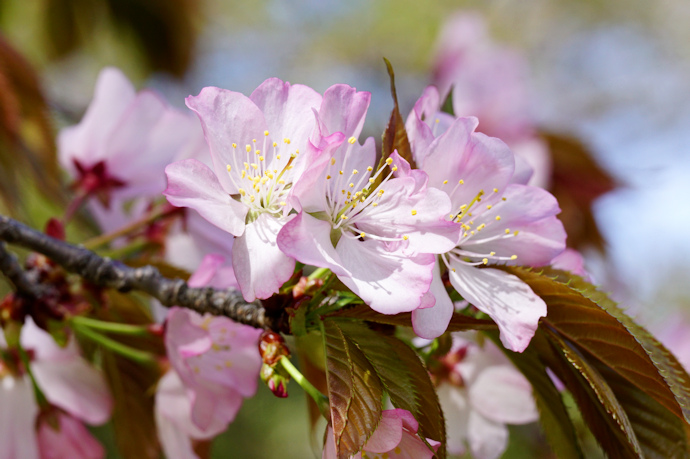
[0,215,287,331]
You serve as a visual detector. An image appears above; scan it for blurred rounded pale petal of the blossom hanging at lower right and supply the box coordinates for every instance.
[469,365,539,424]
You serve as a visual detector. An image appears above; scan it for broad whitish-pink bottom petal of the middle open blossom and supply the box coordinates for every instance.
[336,237,435,314]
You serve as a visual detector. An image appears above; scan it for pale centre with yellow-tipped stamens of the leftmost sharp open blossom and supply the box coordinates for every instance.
[226,131,299,216]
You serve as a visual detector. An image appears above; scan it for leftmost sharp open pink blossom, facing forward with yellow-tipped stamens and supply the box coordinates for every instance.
[165,78,349,301]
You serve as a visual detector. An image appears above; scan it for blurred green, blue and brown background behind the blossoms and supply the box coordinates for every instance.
[0,0,690,458]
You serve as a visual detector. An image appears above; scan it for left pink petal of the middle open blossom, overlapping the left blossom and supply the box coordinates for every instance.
[278,212,349,276]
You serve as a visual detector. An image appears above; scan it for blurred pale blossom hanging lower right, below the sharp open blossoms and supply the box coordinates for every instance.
[431,333,539,459]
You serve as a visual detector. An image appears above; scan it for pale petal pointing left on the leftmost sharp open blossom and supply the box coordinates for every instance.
[164,159,248,236]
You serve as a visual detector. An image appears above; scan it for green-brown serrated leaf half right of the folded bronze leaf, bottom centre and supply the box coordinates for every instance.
[338,320,446,458]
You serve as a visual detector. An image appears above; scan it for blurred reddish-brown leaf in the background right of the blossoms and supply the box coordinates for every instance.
[542,132,617,250]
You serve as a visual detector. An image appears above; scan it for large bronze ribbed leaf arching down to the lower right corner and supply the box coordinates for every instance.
[505,268,690,457]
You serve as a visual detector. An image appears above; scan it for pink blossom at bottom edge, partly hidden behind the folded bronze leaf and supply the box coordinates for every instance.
[322,409,440,459]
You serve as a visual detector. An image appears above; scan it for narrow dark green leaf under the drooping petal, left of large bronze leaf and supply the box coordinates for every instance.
[485,332,583,459]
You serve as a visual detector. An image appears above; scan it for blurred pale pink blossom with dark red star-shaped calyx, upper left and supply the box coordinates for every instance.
[58,67,203,207]
